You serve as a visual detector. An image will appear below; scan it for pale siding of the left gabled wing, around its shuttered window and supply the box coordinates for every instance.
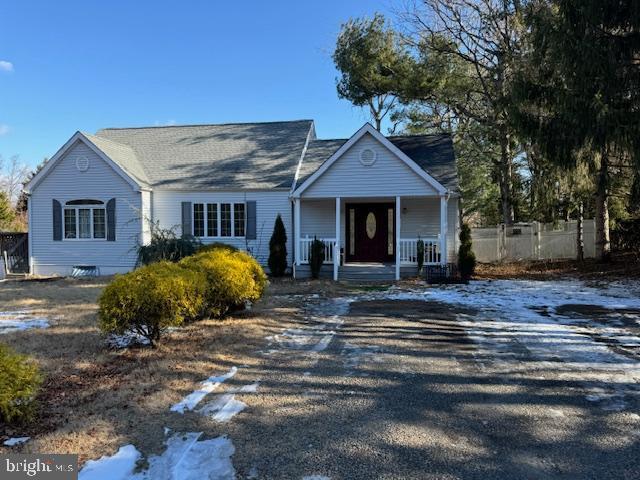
[30,141,142,275]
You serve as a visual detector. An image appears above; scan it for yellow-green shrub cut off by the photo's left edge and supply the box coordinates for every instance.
[0,345,42,423]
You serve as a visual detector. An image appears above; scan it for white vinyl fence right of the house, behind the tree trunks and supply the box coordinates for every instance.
[471,220,596,262]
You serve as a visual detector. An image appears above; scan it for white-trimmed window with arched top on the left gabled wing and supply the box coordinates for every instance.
[64,199,107,240]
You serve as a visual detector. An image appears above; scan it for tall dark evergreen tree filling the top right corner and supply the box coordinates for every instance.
[510,0,640,259]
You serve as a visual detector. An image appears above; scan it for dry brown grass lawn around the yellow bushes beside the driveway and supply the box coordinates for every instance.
[0,279,319,461]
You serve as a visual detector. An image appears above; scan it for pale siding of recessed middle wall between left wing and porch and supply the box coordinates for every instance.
[152,190,293,267]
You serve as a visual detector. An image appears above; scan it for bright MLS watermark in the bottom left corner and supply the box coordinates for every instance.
[0,453,78,480]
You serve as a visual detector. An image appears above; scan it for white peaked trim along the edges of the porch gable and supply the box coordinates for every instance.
[291,123,447,198]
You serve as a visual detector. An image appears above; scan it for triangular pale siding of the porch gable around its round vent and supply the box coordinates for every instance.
[302,134,437,198]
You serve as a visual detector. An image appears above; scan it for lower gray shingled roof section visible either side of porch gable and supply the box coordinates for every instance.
[297,135,459,193]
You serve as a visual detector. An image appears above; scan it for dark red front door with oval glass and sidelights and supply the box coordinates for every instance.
[345,203,395,262]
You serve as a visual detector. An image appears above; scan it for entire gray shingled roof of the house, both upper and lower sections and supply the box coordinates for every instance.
[84,120,458,192]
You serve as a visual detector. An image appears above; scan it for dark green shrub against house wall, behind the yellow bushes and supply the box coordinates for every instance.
[137,224,201,265]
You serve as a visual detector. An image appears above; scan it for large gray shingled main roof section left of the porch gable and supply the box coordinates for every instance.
[92,120,313,189]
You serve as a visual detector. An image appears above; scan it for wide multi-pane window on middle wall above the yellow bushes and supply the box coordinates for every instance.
[193,203,247,238]
